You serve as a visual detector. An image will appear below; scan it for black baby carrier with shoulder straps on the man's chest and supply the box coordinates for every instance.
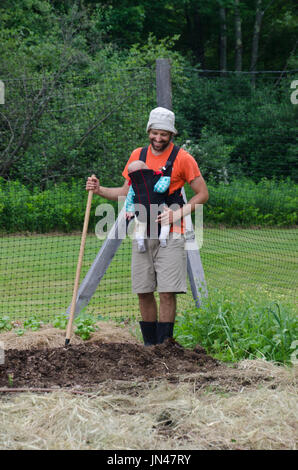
[129,146,184,235]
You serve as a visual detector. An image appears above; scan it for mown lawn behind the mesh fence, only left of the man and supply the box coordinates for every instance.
[0,234,134,319]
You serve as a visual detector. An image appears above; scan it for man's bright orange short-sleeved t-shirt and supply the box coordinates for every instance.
[122,142,201,233]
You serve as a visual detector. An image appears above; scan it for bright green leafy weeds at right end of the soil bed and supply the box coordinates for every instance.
[175,291,298,364]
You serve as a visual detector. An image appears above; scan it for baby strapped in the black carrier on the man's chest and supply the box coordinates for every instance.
[125,160,171,252]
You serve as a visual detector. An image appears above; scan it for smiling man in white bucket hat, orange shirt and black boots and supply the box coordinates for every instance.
[86,107,208,346]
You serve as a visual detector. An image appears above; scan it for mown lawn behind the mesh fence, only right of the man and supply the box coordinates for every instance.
[201,229,298,297]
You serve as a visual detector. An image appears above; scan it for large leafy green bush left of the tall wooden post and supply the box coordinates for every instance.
[0,2,153,187]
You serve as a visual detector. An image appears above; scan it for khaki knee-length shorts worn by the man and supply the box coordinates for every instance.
[131,234,187,294]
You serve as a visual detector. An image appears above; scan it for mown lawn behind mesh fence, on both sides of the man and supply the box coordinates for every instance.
[0,229,297,319]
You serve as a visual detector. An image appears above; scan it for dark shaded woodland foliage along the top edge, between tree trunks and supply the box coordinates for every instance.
[47,0,297,70]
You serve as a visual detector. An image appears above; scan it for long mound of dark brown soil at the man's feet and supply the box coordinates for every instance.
[0,340,219,388]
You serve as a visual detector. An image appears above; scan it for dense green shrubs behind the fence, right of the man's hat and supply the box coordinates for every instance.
[174,71,298,181]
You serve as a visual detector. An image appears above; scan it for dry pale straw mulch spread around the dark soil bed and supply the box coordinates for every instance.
[0,325,298,450]
